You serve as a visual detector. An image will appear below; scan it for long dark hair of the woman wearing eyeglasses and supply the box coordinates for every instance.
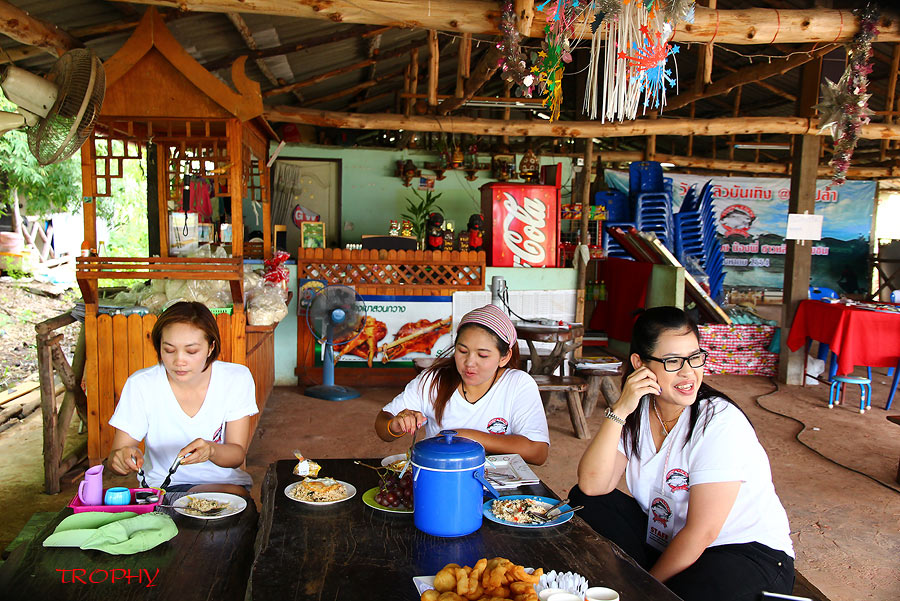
[622,307,753,459]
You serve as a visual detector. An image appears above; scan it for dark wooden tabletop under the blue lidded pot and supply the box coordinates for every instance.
[248,459,678,601]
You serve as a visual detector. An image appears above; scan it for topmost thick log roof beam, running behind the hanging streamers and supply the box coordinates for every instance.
[115,0,900,44]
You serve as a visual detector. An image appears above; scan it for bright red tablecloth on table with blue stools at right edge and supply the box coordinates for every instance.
[787,300,900,374]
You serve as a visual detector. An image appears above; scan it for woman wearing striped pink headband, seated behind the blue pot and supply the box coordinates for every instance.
[375,305,550,465]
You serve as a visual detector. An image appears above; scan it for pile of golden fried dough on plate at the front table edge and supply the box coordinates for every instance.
[413,557,544,601]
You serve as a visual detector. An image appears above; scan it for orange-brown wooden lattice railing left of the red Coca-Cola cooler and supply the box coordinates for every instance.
[297,248,485,296]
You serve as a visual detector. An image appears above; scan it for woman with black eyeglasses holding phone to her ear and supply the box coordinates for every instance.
[569,307,794,601]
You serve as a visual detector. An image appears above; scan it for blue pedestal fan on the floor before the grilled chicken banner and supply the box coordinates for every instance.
[304,285,366,401]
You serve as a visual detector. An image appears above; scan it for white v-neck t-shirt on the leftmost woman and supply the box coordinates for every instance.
[109,361,259,486]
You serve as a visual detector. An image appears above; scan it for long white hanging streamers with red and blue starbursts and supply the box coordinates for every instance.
[584,0,694,122]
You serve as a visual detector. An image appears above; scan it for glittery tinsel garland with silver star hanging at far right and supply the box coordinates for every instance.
[816,3,879,188]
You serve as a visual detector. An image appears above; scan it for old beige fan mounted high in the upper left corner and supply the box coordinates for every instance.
[0,48,106,165]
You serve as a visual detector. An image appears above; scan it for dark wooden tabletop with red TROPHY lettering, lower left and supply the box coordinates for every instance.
[0,500,259,601]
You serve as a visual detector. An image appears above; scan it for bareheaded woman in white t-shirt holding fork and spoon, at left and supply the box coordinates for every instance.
[108,302,258,500]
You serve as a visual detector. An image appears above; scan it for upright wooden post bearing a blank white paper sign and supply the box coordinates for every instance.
[778,59,822,385]
